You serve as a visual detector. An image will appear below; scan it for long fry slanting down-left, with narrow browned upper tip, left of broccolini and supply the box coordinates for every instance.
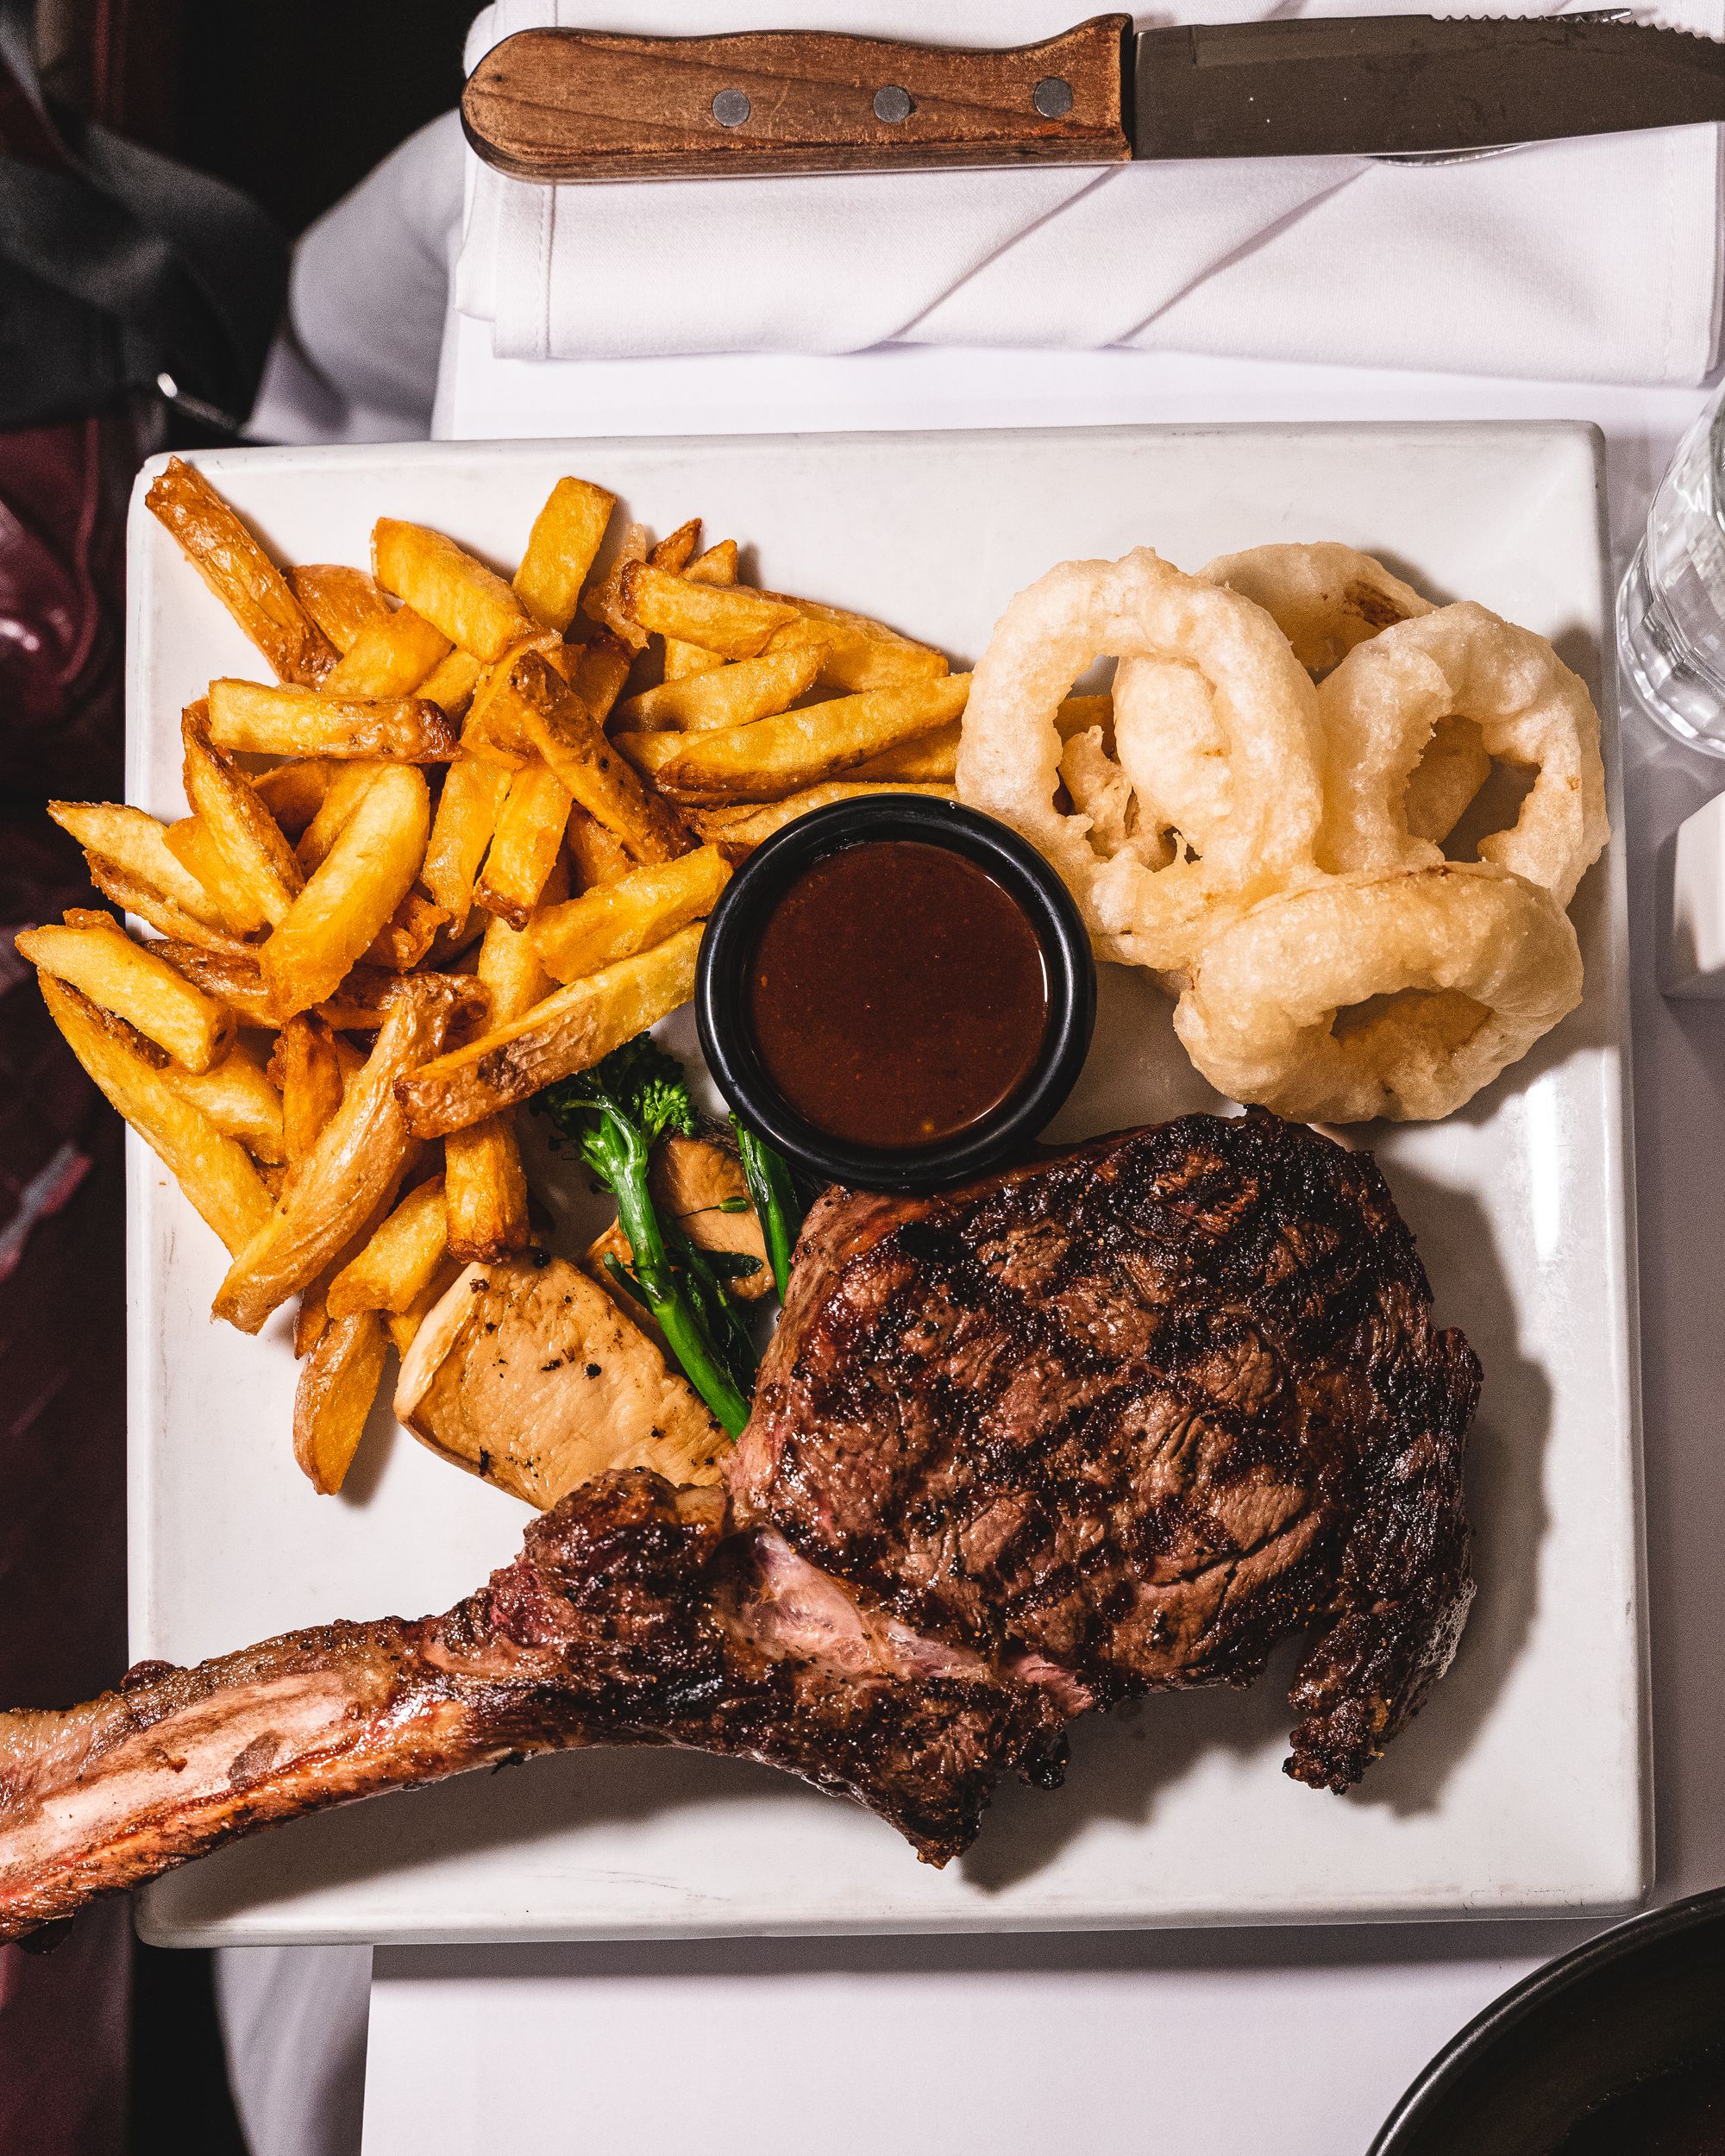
[216,973,481,1332]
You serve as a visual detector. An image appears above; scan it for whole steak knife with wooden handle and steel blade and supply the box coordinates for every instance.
[461,13,1725,181]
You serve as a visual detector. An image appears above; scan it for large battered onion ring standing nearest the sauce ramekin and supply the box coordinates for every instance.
[957,548,1322,977]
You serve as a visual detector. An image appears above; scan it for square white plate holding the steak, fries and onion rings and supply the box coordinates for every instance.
[129,425,1650,1943]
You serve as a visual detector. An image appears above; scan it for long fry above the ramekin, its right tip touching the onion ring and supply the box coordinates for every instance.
[617,675,970,805]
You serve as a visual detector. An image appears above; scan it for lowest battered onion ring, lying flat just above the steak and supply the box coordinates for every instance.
[1173,862,1581,1124]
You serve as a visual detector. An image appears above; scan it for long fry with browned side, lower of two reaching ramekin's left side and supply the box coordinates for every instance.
[399,927,701,1138]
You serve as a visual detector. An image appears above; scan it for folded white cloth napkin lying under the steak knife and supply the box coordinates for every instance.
[455,0,1725,384]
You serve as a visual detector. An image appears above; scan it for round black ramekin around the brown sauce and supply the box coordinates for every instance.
[694,793,1095,1190]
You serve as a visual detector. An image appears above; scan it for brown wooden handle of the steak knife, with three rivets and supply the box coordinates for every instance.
[461,16,1132,181]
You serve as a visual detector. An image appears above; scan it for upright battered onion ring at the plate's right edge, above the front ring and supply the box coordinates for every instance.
[1318,599,1611,906]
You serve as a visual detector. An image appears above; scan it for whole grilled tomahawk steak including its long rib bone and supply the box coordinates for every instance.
[0,1112,1479,1939]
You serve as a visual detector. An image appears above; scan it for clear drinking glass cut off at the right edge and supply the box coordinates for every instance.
[1617,395,1725,757]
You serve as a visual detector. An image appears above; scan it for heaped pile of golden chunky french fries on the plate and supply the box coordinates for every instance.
[17,460,969,1490]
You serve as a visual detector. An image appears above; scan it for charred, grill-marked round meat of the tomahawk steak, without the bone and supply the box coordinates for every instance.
[731,1111,1479,1789]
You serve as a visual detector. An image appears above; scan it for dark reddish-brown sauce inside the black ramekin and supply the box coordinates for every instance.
[749,839,1048,1151]
